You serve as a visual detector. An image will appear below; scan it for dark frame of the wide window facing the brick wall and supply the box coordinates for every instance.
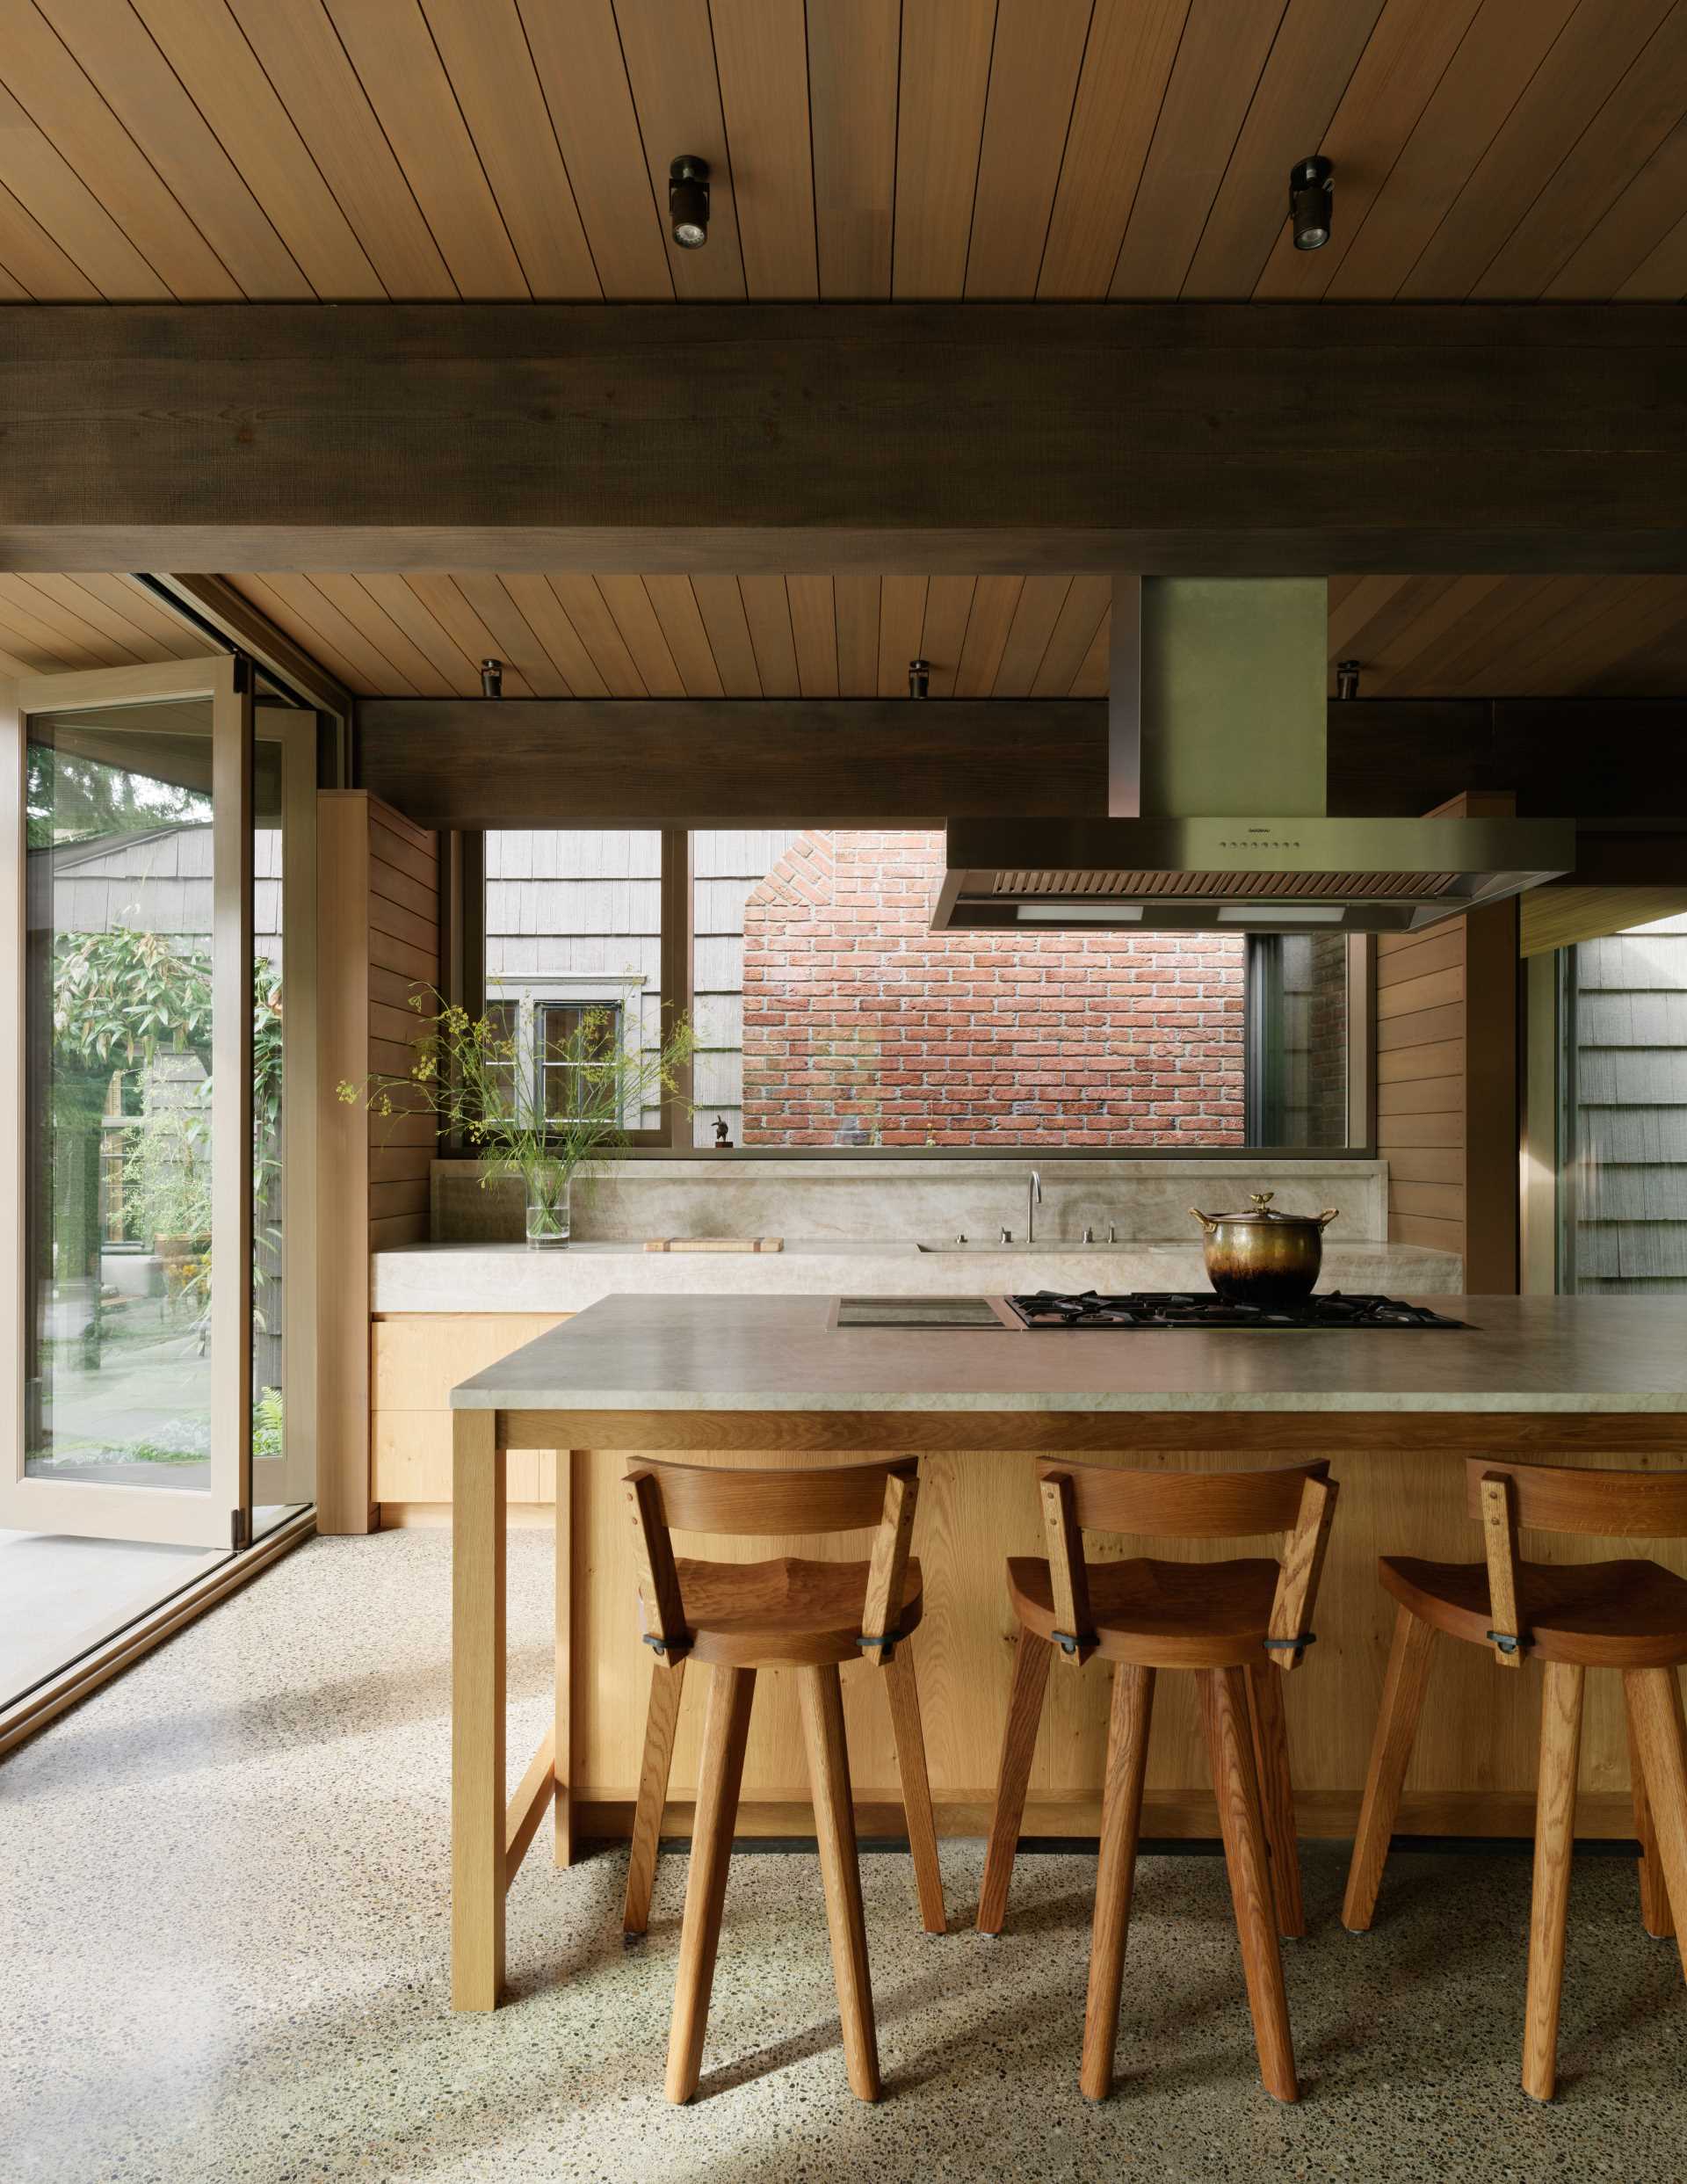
[460,816,1377,1165]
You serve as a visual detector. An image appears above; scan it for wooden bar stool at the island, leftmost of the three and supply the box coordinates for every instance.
[622,1456,947,2101]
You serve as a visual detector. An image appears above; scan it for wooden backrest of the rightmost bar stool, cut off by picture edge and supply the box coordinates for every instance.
[1465,1456,1687,1669]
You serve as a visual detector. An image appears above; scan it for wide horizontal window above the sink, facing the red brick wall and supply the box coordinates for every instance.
[484,828,1368,1156]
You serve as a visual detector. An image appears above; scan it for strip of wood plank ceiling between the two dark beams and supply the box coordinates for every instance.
[206,570,1687,699]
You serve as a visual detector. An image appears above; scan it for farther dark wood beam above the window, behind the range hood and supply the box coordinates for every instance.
[356,697,1687,828]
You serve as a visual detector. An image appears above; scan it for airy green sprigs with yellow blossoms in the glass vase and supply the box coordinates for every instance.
[338,987,696,1184]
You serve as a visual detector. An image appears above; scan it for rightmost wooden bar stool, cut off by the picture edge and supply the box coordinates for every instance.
[1343,1456,1687,2101]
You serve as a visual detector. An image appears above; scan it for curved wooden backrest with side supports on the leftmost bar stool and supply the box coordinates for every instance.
[622,1456,919,1666]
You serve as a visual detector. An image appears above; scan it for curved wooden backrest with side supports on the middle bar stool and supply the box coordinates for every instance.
[1037,1459,1336,1669]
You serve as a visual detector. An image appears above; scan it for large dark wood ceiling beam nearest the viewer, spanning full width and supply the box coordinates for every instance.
[0,303,1687,575]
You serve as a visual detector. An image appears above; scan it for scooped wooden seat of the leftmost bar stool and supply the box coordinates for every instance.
[655,1555,925,1669]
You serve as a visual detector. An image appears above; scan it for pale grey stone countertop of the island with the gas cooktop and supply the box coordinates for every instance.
[452,1269,1687,1413]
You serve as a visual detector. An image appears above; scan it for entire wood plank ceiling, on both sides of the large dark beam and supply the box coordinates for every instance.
[0,0,1687,697]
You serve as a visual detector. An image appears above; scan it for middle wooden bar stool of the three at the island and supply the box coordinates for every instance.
[978,1463,1336,2101]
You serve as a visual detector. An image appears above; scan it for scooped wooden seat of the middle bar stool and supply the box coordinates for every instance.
[1009,1555,1281,1669]
